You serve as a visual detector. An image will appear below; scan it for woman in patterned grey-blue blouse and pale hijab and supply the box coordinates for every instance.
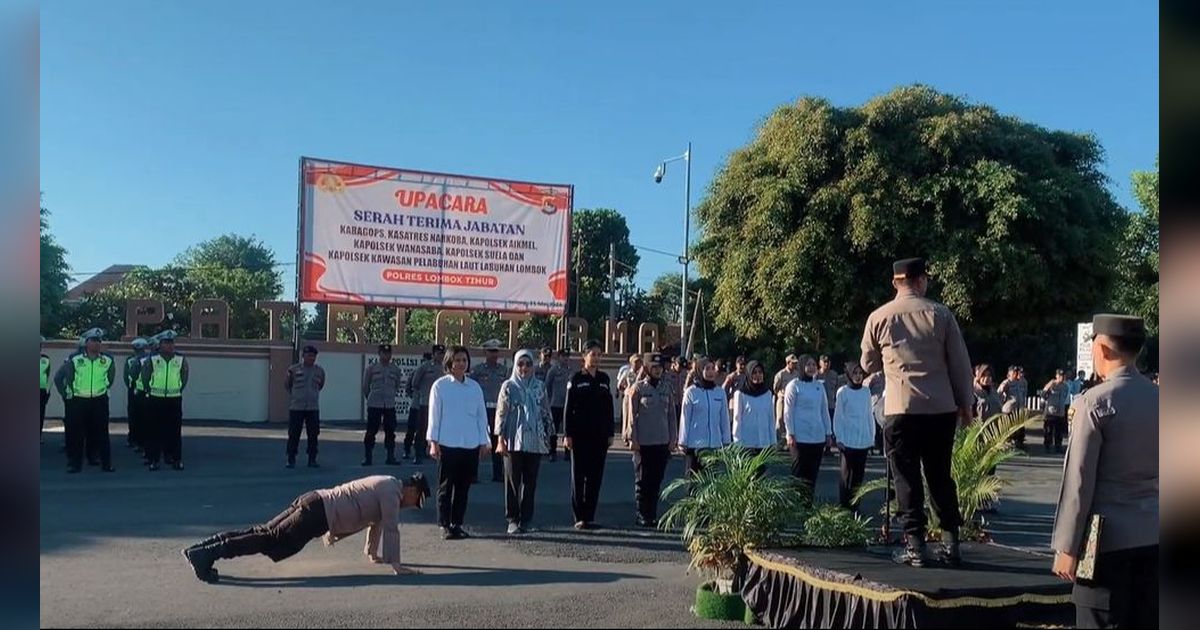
[496,350,554,535]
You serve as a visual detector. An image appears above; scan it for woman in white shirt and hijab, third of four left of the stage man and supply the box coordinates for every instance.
[784,355,833,496]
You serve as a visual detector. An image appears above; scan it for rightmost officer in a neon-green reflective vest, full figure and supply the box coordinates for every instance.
[140,330,190,470]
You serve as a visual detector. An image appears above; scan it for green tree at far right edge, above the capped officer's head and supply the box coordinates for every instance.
[1112,163,1158,336]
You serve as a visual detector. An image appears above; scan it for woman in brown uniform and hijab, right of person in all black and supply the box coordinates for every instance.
[622,354,679,527]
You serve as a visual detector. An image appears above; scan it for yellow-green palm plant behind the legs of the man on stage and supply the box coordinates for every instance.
[854,412,1032,541]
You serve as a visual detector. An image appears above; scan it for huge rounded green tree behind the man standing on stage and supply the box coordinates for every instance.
[696,85,1124,354]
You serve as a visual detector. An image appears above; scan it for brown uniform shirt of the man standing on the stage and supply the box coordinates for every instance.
[862,292,974,415]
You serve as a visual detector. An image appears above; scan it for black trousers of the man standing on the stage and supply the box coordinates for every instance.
[883,413,962,539]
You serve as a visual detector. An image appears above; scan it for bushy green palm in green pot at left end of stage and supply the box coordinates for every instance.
[659,445,810,619]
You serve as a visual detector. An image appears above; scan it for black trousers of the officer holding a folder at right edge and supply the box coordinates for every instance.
[1072,545,1158,628]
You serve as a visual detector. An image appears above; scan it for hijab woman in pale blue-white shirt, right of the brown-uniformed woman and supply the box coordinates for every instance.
[679,358,732,474]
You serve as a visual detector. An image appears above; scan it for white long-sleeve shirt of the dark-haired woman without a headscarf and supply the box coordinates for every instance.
[425,374,491,449]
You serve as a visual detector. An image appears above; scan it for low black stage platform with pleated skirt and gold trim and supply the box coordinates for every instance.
[734,544,1075,628]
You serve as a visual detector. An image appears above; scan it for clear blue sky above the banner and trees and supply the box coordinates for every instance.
[41,0,1158,294]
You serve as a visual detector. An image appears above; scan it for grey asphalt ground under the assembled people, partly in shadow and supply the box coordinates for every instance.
[41,422,1061,628]
